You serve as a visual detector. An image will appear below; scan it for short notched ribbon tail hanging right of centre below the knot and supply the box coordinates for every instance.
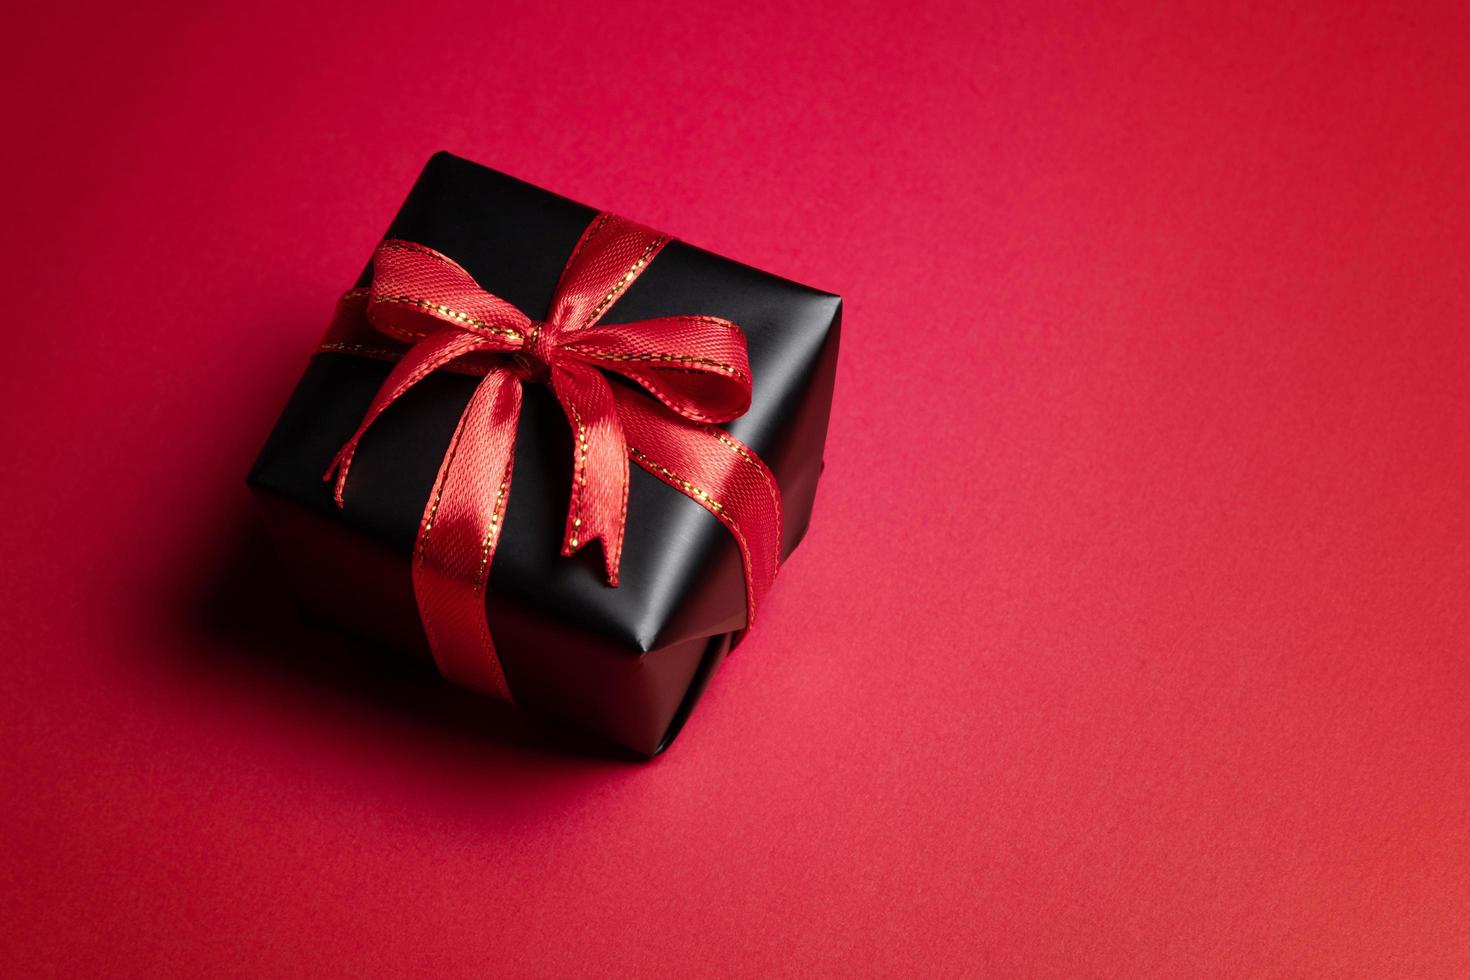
[551,363,628,586]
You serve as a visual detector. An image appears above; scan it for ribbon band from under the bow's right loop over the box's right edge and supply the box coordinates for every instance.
[614,388,781,629]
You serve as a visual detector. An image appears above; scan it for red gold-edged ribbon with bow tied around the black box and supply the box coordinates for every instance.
[322,213,781,701]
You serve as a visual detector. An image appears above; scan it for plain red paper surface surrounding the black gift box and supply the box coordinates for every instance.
[0,3,1470,977]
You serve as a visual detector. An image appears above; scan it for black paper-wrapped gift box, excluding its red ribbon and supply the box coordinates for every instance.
[248,153,842,755]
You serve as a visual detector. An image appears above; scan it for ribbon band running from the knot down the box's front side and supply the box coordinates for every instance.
[413,369,520,701]
